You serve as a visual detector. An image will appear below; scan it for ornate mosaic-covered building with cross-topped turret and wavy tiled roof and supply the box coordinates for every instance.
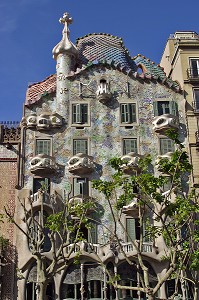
[3,13,186,300]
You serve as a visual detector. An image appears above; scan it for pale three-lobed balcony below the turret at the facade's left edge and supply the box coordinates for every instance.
[21,113,63,131]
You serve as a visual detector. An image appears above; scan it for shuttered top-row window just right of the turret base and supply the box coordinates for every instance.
[72,103,88,125]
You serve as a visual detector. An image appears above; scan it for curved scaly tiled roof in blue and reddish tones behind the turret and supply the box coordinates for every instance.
[25,33,181,106]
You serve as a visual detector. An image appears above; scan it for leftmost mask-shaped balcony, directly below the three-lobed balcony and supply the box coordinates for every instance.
[30,154,58,177]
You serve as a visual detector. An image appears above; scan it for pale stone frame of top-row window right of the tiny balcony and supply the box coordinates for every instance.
[119,101,139,127]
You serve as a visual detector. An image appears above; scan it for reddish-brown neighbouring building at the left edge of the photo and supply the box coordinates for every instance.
[0,122,21,300]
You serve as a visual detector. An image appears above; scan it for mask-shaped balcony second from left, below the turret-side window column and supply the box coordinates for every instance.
[67,153,95,174]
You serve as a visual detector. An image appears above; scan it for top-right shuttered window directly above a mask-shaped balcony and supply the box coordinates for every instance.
[153,101,178,117]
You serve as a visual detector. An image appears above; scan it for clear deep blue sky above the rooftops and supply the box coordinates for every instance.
[0,0,199,121]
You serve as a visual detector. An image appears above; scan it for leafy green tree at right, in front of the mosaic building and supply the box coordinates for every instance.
[93,132,199,300]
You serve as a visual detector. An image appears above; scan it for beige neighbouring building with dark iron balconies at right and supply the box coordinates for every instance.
[160,31,199,187]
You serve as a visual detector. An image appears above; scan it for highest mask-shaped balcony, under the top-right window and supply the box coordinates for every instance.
[152,114,179,133]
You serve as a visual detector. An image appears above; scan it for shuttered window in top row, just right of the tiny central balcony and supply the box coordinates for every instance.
[120,103,137,126]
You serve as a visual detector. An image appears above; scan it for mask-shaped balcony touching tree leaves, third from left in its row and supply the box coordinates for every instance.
[121,152,143,175]
